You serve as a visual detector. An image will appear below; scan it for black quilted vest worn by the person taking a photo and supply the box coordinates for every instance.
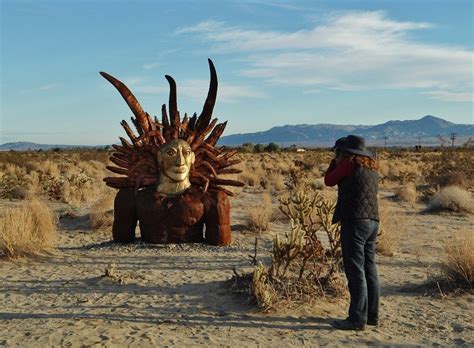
[332,167,379,223]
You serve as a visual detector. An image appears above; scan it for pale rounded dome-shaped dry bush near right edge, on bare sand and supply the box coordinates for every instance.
[427,186,474,213]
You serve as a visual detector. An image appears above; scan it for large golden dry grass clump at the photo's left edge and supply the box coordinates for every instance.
[0,198,57,259]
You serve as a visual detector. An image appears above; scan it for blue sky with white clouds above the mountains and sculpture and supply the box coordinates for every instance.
[0,0,474,144]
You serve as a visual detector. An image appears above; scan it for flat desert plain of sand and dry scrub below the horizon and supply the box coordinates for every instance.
[0,149,474,347]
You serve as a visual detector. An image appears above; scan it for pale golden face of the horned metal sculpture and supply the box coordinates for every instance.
[158,139,194,183]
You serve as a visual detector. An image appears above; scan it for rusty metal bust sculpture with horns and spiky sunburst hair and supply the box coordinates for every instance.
[100,59,243,245]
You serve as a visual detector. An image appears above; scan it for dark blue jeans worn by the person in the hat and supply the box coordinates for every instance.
[341,219,380,324]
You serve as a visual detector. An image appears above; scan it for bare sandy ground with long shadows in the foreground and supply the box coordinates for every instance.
[0,191,474,347]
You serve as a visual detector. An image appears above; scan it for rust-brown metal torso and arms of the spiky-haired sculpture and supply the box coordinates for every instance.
[113,186,231,245]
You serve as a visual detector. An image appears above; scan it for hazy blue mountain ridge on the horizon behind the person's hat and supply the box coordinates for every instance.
[219,115,474,146]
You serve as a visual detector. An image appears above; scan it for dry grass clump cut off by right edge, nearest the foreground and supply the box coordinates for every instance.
[441,232,474,291]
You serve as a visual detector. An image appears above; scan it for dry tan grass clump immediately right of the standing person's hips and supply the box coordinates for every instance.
[377,206,407,256]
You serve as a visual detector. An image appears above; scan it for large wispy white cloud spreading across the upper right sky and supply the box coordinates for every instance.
[177,11,474,101]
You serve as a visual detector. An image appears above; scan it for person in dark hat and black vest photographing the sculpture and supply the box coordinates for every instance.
[324,135,379,330]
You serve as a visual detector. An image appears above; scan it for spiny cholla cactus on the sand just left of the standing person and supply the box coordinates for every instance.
[241,178,345,310]
